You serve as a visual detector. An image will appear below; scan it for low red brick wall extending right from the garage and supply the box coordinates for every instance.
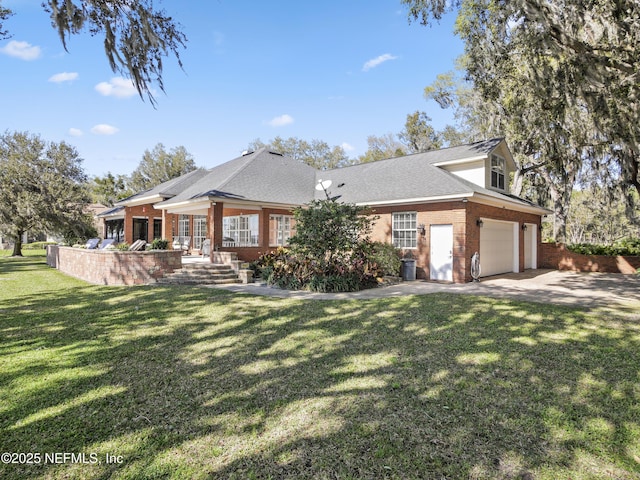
[542,243,640,273]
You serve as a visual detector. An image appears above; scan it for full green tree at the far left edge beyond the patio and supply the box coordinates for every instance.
[0,132,92,256]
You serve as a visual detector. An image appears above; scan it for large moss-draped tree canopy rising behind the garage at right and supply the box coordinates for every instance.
[402,0,640,241]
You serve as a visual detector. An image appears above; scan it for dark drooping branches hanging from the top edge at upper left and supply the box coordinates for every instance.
[0,0,187,105]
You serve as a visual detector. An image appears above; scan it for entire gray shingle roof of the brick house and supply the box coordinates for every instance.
[121,138,544,214]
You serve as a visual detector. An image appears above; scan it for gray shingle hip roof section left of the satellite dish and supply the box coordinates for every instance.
[158,148,316,207]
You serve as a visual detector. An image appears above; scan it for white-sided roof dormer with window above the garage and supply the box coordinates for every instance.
[433,140,515,193]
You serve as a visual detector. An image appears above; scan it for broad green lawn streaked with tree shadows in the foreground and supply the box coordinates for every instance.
[0,256,640,480]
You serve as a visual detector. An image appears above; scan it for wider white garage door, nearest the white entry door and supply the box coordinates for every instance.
[480,218,518,277]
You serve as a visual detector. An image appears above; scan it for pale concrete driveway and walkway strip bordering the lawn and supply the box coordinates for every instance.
[215,270,640,313]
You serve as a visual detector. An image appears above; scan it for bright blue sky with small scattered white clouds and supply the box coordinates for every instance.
[0,0,463,175]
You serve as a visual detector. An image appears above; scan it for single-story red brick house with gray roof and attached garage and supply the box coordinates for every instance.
[110,138,550,283]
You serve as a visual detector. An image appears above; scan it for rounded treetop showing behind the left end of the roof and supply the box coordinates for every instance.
[130,143,196,192]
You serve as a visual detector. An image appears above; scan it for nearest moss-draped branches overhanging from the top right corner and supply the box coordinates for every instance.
[401,0,640,197]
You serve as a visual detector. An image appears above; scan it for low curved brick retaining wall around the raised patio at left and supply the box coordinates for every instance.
[47,245,182,285]
